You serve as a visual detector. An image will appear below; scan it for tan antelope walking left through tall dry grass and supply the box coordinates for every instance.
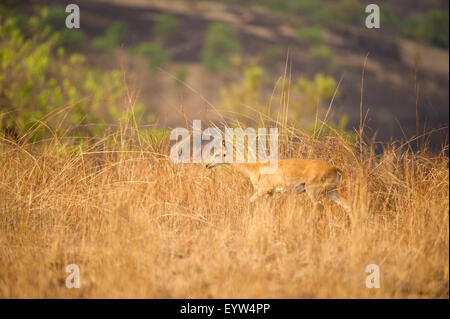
[206,143,350,213]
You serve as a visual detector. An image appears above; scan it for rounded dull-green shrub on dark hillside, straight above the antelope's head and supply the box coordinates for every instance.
[202,22,239,70]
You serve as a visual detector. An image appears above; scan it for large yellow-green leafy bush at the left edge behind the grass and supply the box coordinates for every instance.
[0,8,131,137]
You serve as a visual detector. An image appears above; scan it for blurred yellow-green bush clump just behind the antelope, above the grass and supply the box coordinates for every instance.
[219,60,348,140]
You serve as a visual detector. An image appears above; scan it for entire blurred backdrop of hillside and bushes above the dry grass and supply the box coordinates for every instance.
[0,0,449,149]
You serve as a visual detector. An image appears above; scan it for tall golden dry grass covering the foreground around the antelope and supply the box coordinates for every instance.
[0,115,449,298]
